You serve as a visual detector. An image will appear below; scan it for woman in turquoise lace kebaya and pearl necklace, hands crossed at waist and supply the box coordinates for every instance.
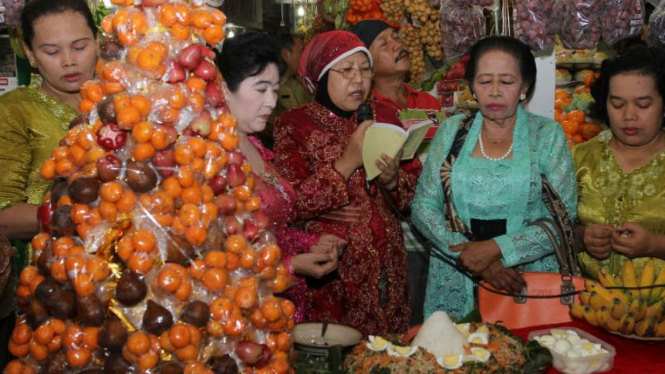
[411,37,576,318]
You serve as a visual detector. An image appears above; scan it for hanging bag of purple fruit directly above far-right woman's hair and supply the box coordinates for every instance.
[603,0,644,45]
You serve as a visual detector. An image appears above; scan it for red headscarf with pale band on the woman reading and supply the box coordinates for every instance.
[298,30,372,94]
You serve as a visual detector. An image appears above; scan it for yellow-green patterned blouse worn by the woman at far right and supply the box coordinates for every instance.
[573,130,665,279]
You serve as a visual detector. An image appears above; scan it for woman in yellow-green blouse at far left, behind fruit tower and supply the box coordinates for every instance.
[0,0,98,367]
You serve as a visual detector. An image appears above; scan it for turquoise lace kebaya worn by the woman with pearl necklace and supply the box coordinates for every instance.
[411,108,577,318]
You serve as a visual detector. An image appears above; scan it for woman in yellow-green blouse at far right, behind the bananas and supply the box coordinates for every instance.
[573,47,665,279]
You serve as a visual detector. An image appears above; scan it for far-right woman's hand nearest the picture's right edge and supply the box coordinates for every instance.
[612,222,657,258]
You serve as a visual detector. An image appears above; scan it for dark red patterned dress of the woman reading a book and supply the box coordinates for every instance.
[275,102,420,335]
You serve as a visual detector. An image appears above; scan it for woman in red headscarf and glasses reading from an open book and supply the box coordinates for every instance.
[275,31,420,335]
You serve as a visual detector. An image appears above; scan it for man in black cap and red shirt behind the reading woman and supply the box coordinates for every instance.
[351,20,441,110]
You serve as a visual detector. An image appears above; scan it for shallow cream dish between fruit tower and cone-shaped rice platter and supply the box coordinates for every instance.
[292,323,363,348]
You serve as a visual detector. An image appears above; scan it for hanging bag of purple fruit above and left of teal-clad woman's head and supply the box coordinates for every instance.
[440,0,485,58]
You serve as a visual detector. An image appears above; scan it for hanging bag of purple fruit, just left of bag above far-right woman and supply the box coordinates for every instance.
[559,0,606,49]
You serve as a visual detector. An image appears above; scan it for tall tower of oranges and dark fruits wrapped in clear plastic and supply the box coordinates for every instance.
[5,0,294,374]
